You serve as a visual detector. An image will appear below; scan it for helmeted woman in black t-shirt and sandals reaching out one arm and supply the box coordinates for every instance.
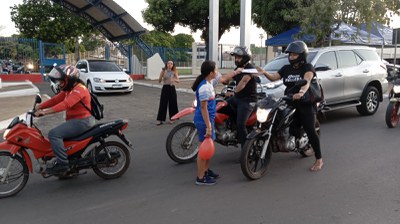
[257,41,324,171]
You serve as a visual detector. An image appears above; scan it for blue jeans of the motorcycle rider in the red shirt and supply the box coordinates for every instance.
[49,116,95,164]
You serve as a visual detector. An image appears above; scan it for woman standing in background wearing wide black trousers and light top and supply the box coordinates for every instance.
[157,61,179,125]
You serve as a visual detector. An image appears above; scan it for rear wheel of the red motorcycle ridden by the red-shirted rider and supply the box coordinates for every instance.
[93,141,131,179]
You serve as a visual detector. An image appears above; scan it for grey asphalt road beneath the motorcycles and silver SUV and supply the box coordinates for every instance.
[0,86,400,224]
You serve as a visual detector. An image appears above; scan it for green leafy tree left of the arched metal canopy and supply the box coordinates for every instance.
[11,0,95,49]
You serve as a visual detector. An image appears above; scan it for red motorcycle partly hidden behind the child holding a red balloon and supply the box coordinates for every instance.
[166,86,257,163]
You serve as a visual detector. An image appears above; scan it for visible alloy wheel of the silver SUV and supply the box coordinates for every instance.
[357,86,379,115]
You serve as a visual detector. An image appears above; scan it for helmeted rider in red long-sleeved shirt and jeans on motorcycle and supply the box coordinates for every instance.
[35,65,95,175]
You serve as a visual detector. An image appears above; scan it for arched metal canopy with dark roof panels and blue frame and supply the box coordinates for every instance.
[52,0,153,55]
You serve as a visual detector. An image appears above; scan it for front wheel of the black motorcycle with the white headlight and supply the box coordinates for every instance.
[240,138,272,180]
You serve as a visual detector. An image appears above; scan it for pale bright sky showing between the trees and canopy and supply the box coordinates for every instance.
[0,0,400,46]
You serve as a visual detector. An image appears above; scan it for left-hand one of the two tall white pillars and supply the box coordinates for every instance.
[208,0,219,64]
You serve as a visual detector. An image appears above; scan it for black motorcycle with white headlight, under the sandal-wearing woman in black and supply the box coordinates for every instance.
[240,80,321,180]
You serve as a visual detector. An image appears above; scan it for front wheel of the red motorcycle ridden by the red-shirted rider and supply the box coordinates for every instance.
[0,152,29,198]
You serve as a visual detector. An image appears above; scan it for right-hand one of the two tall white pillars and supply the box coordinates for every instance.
[240,0,251,49]
